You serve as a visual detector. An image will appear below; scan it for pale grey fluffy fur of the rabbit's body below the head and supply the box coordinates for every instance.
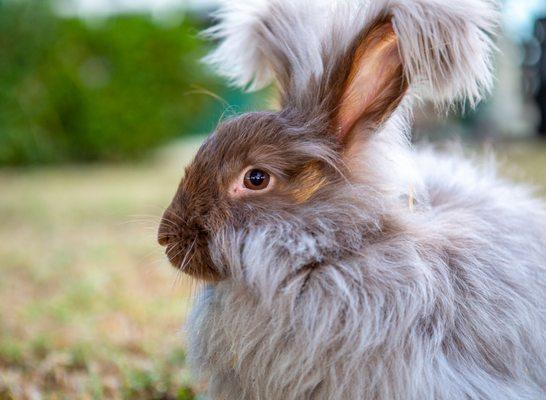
[189,152,546,400]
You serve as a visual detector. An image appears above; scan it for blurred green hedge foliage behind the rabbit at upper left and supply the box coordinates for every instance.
[0,0,254,165]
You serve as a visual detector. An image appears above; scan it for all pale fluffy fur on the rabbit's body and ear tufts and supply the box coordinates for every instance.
[188,0,546,400]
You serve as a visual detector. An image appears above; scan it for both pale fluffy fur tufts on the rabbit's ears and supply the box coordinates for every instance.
[205,0,499,106]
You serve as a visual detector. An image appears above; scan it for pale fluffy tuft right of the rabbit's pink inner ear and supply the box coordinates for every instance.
[389,0,499,106]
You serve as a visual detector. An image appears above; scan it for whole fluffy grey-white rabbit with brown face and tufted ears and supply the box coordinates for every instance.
[158,0,546,400]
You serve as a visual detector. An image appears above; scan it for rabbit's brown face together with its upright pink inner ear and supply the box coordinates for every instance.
[158,19,407,281]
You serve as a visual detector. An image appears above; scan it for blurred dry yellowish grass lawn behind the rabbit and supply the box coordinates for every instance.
[0,137,546,400]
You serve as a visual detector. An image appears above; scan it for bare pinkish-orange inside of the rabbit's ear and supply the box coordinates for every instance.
[337,22,405,141]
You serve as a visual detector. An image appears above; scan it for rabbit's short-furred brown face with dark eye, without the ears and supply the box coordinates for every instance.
[158,113,338,281]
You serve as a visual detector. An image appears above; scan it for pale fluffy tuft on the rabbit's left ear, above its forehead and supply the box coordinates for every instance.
[204,0,331,95]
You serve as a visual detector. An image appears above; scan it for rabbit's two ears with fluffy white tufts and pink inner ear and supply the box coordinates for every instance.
[206,0,499,117]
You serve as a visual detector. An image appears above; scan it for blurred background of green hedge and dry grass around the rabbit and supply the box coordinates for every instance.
[0,0,546,400]
